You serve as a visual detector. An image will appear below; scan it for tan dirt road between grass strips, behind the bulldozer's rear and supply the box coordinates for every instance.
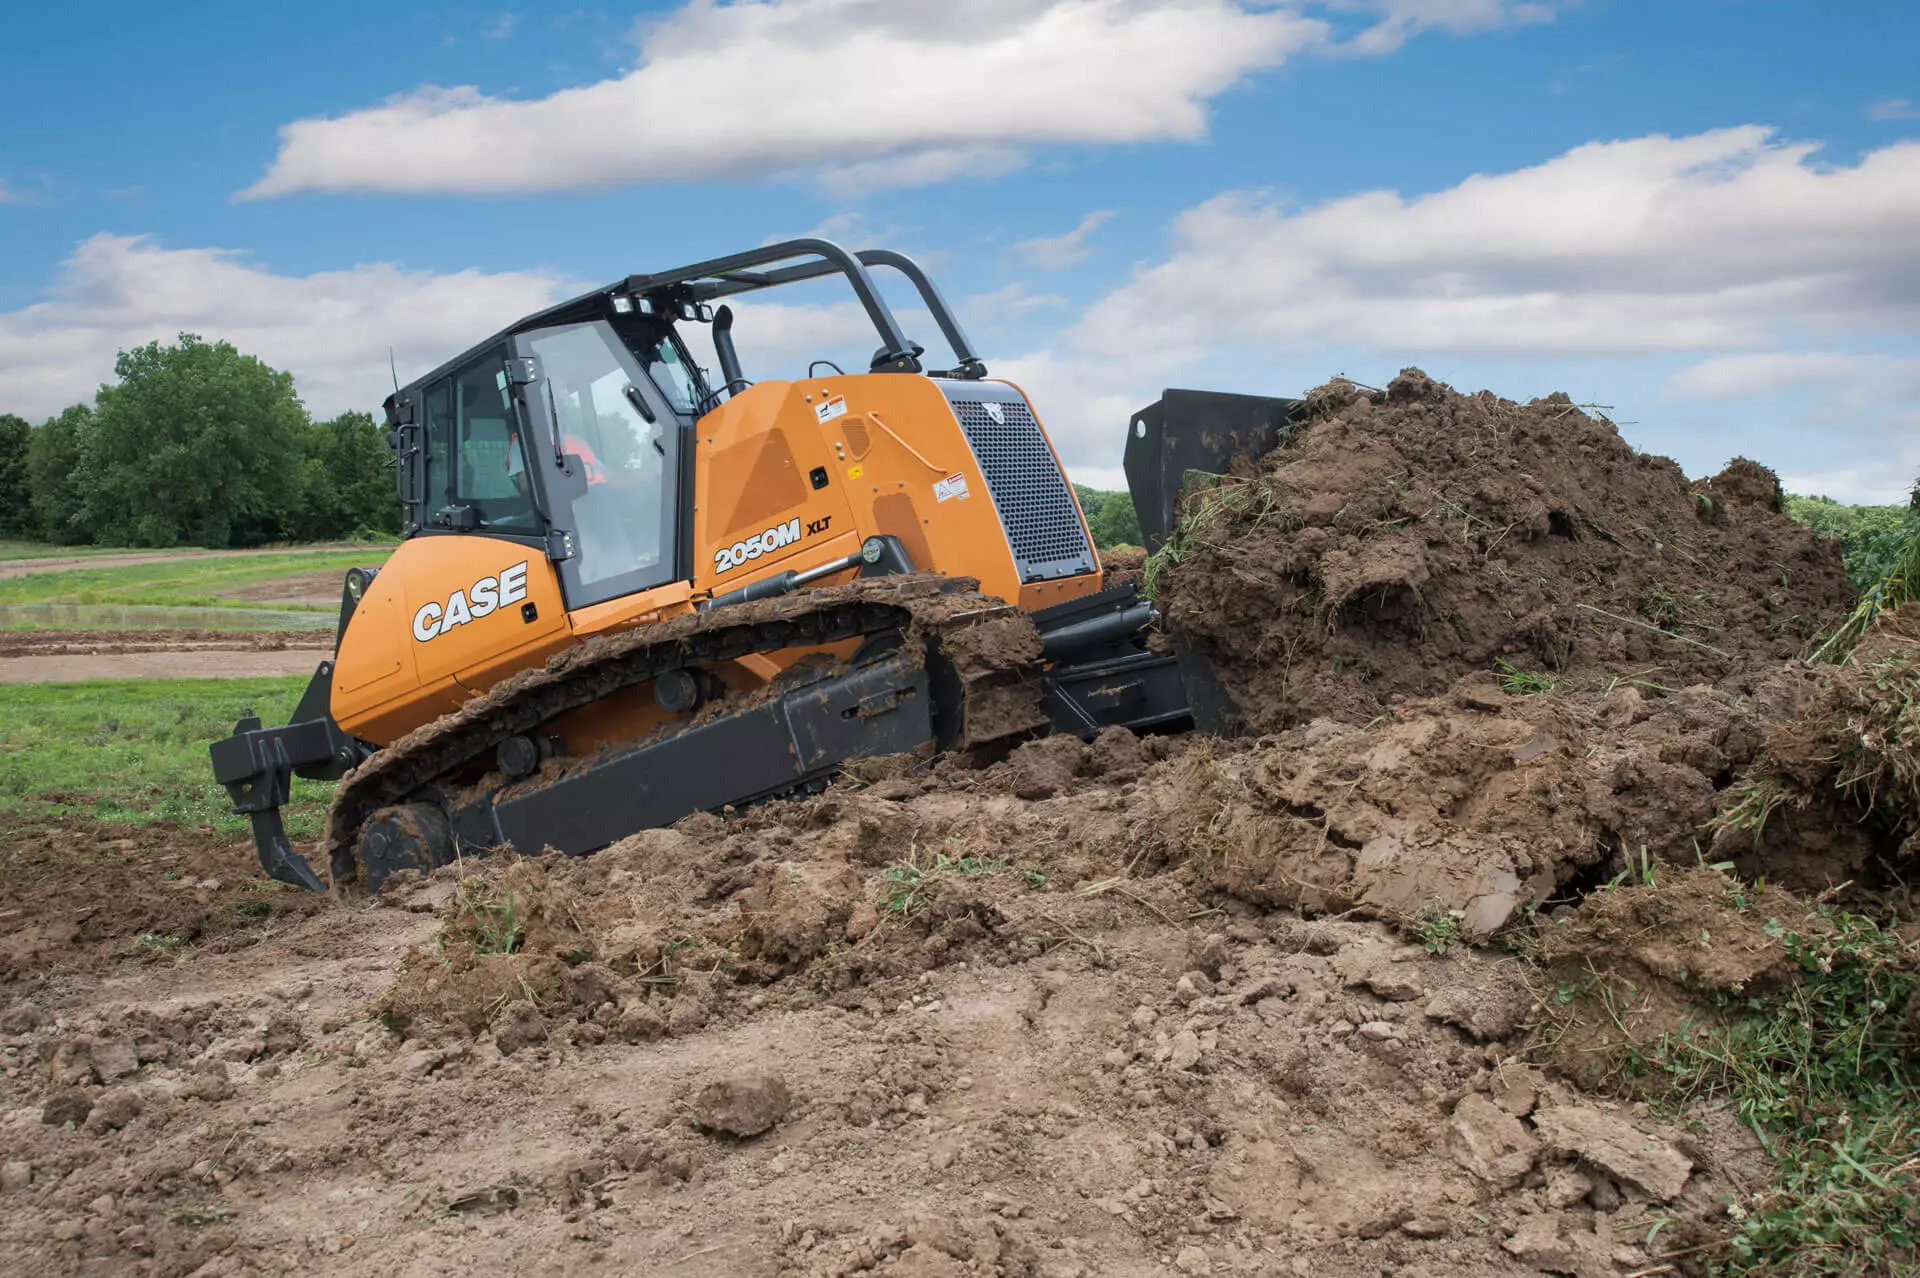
[0,629,334,683]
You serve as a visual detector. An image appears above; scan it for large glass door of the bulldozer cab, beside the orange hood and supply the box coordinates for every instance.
[526,322,680,608]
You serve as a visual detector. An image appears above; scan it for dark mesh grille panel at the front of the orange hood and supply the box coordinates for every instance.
[952,399,1092,578]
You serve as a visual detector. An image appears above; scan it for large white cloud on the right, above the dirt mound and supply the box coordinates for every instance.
[1077,127,1920,359]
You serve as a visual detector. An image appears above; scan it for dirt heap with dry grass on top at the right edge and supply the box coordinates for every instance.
[1713,604,1920,890]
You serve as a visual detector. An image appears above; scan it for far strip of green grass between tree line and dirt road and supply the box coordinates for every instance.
[0,547,388,612]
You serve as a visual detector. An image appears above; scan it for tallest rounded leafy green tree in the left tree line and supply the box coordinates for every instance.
[81,334,307,545]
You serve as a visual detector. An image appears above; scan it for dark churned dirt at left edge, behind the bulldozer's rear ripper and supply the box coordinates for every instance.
[0,819,326,986]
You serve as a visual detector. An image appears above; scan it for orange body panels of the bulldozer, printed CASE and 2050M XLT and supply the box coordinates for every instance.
[332,374,1100,754]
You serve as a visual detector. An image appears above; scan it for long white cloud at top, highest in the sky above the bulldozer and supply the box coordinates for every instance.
[242,0,1329,198]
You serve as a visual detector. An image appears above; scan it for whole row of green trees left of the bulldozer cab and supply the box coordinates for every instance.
[0,334,399,547]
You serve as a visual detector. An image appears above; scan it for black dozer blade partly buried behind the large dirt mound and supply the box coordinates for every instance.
[1123,390,1306,737]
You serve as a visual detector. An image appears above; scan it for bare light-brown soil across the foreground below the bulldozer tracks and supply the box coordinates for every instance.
[0,756,1734,1278]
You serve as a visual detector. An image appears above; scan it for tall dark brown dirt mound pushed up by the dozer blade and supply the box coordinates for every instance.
[1156,368,1851,731]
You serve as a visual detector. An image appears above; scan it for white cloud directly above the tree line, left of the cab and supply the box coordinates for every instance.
[0,234,586,420]
